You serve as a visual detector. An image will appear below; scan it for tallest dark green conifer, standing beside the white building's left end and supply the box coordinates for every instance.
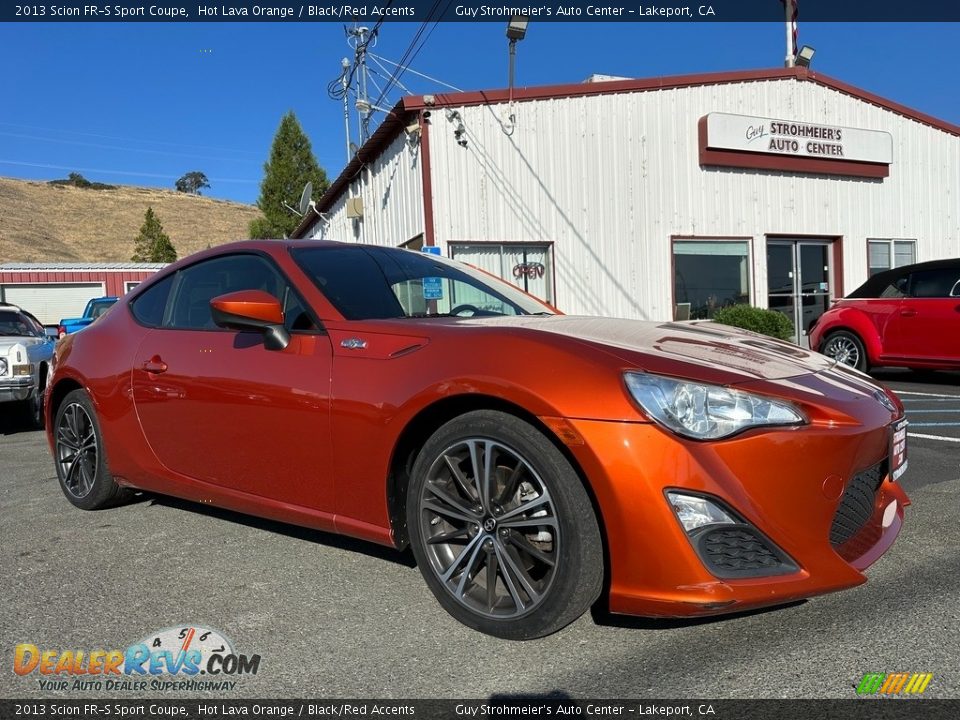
[250,110,329,238]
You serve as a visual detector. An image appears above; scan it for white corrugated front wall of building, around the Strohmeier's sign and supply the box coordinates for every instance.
[430,79,960,320]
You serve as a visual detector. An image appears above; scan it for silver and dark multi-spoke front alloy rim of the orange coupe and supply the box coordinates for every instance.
[419,438,561,619]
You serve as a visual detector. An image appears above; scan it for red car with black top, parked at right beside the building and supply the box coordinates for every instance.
[810,259,960,372]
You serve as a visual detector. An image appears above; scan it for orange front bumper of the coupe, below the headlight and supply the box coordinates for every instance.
[570,408,909,617]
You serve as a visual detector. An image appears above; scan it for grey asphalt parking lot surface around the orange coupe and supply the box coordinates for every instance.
[0,371,960,698]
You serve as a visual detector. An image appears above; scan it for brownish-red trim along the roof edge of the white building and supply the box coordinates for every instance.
[291,67,960,238]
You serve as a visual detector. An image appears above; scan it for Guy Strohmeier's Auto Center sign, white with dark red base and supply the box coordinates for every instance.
[700,113,893,177]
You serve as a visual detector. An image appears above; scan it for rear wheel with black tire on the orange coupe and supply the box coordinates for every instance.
[53,390,131,510]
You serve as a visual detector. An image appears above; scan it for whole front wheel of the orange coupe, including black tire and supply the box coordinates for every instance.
[407,410,603,640]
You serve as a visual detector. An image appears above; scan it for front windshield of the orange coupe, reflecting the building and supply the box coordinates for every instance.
[293,245,552,320]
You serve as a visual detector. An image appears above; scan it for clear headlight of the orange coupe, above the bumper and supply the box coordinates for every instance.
[624,372,806,440]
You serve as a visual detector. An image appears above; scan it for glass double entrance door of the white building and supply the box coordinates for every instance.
[767,238,833,347]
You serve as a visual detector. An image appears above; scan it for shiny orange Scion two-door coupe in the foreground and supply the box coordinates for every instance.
[46,241,908,639]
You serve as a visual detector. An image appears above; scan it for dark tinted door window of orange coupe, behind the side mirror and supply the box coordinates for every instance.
[166,255,286,330]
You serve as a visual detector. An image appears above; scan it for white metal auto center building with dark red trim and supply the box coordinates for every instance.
[294,68,960,344]
